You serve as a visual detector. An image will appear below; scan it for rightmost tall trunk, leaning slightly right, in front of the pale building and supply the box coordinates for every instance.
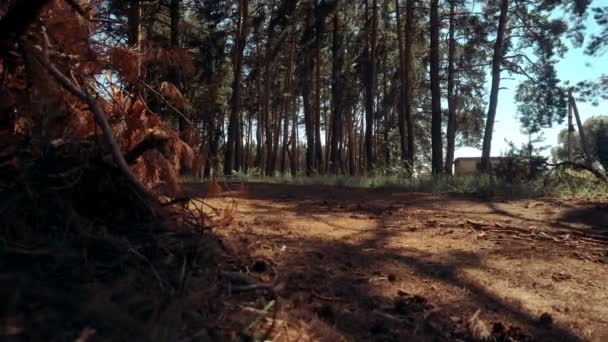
[481,0,509,171]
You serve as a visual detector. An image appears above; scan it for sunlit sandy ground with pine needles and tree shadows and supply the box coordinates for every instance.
[185,184,608,341]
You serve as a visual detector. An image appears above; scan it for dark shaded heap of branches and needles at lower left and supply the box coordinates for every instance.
[0,148,233,342]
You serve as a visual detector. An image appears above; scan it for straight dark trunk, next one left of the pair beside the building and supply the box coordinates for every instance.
[403,0,416,172]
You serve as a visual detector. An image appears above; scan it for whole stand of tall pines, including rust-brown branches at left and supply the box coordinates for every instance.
[0,0,606,190]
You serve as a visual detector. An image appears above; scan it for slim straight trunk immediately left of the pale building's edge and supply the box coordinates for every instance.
[445,0,458,175]
